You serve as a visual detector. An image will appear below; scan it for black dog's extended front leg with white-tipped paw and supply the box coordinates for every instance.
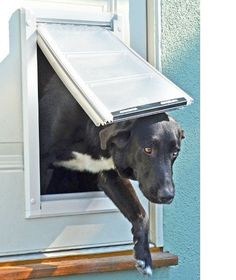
[99,171,152,275]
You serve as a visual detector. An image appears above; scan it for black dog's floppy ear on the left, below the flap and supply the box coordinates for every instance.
[99,121,135,150]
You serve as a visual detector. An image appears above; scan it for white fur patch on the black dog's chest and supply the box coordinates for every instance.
[54,152,115,173]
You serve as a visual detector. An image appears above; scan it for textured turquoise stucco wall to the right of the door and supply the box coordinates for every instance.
[42,0,200,280]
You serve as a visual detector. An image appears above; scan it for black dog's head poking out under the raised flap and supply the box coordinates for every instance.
[100,113,184,204]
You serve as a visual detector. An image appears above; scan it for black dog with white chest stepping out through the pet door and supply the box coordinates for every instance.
[38,47,184,275]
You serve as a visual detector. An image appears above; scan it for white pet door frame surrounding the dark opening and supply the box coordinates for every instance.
[21,5,133,218]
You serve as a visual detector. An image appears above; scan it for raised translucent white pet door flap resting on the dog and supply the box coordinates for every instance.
[38,23,192,126]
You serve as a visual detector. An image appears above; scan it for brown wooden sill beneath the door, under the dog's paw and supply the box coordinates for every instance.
[0,248,178,280]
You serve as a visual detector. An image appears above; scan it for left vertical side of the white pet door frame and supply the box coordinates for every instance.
[20,9,40,216]
